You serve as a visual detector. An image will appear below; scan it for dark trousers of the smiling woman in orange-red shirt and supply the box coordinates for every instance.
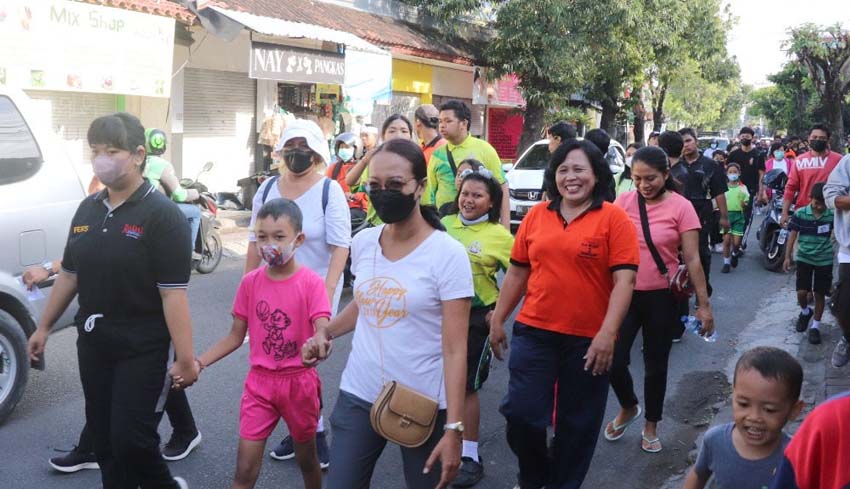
[499,322,608,489]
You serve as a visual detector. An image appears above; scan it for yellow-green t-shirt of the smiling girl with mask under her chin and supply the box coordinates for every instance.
[442,214,514,307]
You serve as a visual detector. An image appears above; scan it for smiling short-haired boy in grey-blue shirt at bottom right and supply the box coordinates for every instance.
[684,346,803,489]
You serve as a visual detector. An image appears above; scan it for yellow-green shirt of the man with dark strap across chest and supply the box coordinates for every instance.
[422,136,505,209]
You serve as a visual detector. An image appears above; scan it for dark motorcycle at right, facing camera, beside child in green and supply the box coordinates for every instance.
[756,168,794,272]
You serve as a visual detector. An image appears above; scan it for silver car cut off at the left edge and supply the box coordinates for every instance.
[0,87,85,422]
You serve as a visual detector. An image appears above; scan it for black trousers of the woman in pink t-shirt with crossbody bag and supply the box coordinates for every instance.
[611,289,677,422]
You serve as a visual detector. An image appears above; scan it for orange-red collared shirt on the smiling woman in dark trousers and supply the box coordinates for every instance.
[511,199,640,338]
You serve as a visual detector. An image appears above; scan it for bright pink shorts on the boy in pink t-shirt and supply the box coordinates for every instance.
[239,367,322,443]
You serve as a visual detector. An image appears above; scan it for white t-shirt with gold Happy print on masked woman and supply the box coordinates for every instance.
[340,226,474,409]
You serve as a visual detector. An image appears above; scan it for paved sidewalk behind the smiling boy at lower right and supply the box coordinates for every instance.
[663,283,850,489]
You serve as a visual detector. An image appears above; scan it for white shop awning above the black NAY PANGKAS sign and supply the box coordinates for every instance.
[209,6,389,55]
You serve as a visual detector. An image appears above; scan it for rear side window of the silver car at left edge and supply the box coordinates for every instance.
[0,96,44,185]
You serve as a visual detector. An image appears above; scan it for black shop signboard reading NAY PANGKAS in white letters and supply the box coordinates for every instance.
[248,42,345,85]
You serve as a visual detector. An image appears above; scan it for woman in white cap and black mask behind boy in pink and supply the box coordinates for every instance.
[245,119,351,469]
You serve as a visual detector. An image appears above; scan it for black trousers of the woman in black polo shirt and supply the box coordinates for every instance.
[77,325,178,489]
